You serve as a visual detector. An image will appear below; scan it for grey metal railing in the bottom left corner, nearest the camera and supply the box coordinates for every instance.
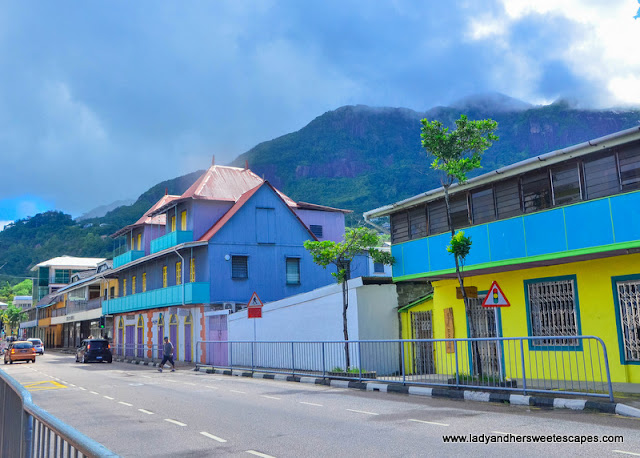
[0,369,118,458]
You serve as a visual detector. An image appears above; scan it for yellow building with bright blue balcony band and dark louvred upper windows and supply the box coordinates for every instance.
[365,124,640,383]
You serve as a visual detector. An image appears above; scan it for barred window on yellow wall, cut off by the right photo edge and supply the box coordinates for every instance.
[616,280,640,361]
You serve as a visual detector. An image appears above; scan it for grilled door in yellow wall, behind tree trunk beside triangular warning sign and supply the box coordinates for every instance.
[467,294,501,377]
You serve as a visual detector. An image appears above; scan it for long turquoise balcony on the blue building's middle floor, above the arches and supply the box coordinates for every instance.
[102,282,210,315]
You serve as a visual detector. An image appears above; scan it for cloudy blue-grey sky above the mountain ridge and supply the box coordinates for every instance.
[0,0,640,228]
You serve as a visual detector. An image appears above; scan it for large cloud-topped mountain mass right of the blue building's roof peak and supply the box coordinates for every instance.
[232,94,640,217]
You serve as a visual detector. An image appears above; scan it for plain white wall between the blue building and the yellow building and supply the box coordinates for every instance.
[228,278,399,374]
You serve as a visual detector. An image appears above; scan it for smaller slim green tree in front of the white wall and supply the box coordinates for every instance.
[304,227,395,371]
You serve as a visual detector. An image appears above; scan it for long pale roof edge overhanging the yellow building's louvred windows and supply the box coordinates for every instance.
[363,126,640,220]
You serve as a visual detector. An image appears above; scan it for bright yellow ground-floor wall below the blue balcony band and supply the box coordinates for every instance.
[422,254,640,383]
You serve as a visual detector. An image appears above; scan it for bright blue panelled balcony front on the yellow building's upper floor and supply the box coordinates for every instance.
[391,191,640,280]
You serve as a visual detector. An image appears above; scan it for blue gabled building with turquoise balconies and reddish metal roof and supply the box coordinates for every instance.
[103,165,376,362]
